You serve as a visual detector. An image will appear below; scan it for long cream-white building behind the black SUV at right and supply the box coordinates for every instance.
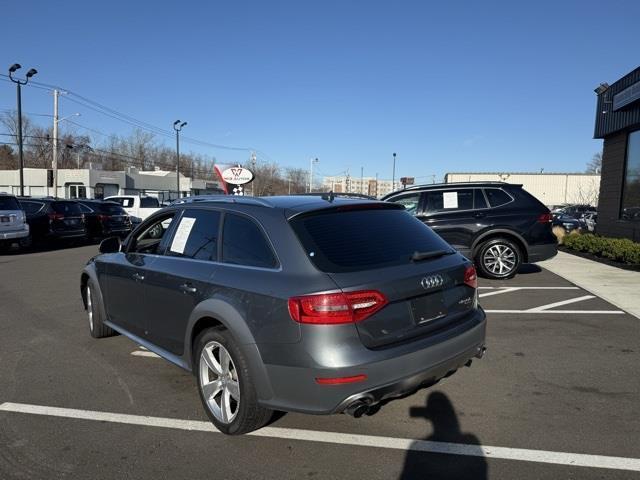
[444,172,600,206]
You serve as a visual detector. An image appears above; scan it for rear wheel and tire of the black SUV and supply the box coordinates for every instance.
[476,237,522,280]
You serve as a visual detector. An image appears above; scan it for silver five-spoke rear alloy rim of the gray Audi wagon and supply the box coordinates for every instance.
[199,342,240,424]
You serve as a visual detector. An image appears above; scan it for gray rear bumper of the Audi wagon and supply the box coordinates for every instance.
[255,309,486,414]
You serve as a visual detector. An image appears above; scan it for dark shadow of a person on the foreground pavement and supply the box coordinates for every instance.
[399,392,488,480]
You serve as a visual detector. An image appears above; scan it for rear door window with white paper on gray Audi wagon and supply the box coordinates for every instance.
[166,208,220,262]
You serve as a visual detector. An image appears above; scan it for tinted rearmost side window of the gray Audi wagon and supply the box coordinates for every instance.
[222,214,278,268]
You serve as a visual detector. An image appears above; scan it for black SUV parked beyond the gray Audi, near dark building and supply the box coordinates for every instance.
[383,182,557,279]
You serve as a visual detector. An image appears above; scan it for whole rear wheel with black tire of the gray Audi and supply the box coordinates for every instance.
[193,328,273,435]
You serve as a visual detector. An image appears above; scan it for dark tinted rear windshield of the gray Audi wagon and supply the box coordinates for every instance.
[291,209,451,273]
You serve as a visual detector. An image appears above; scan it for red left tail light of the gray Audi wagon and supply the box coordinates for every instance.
[289,290,389,325]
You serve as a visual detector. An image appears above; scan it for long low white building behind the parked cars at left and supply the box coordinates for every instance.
[0,167,222,201]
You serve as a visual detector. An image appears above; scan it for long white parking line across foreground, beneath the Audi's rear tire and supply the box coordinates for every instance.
[0,402,640,472]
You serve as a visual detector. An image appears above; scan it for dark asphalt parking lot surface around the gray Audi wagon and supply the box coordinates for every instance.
[0,246,640,479]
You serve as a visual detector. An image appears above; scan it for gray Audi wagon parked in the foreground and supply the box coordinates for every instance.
[81,195,486,434]
